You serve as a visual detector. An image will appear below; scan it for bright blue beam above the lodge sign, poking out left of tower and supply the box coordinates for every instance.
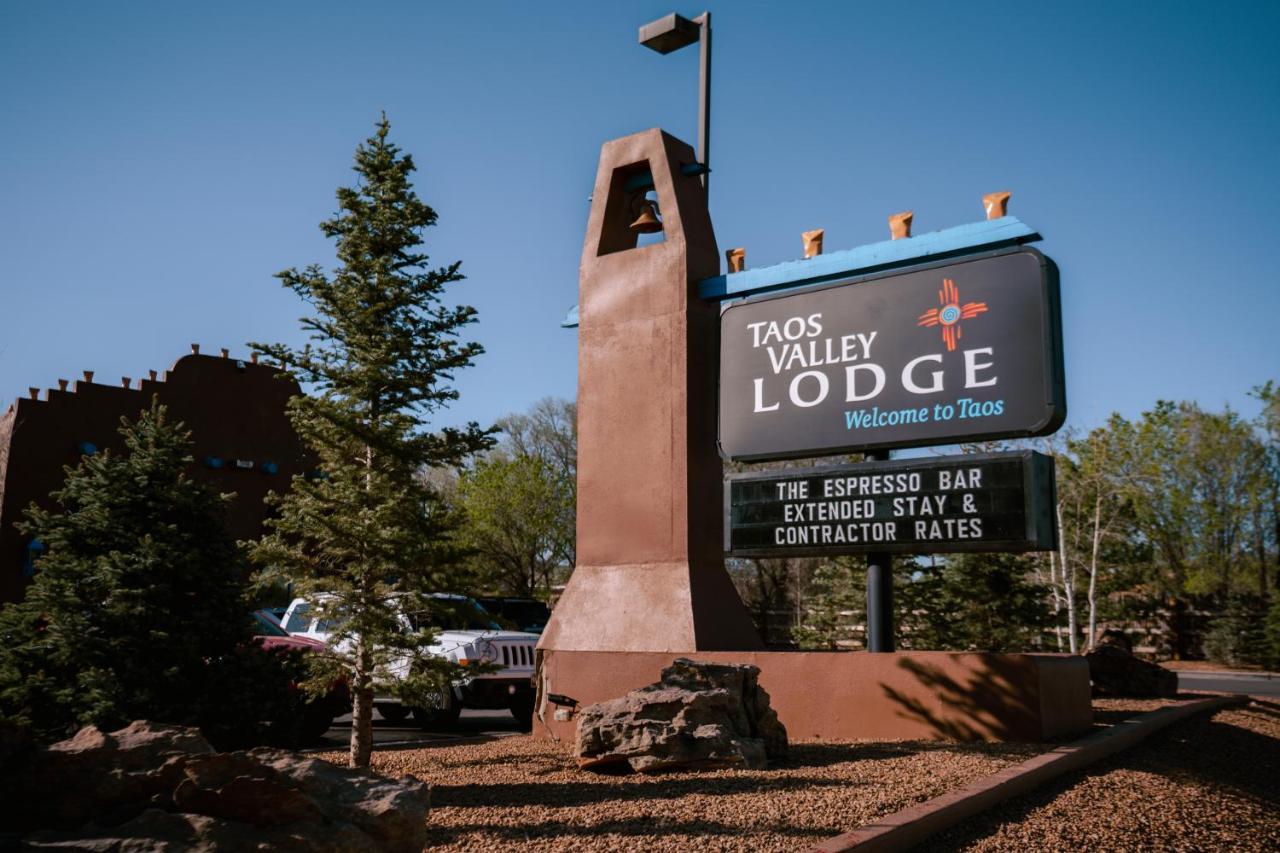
[561,216,1041,329]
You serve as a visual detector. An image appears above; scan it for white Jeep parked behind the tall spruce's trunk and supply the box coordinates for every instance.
[282,593,538,730]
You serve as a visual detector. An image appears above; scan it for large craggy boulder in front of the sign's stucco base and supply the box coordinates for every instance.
[576,658,787,772]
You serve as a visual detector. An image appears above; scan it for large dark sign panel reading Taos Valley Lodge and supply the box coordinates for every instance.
[719,247,1066,460]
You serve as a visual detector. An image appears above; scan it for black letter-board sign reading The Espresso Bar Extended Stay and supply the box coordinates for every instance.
[724,451,1057,557]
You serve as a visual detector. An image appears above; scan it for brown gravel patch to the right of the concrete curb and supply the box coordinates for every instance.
[924,702,1280,852]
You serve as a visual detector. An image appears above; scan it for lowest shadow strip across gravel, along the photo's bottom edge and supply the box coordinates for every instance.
[428,816,831,849]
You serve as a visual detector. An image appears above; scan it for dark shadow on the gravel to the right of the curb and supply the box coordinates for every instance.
[915,697,1280,852]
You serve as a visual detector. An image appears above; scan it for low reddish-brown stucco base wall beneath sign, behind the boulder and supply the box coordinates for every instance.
[534,649,1093,743]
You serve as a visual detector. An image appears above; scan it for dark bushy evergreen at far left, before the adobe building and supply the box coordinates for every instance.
[0,402,250,739]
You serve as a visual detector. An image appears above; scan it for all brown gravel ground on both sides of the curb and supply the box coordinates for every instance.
[316,699,1280,852]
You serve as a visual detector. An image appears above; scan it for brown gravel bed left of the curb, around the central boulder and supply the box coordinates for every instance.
[317,735,1042,852]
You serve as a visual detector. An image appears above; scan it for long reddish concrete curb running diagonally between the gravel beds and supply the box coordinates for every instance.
[812,695,1249,853]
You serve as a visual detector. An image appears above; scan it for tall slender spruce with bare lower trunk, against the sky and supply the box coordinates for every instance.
[251,115,492,767]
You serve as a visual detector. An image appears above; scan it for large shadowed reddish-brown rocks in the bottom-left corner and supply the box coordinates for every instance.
[0,721,430,853]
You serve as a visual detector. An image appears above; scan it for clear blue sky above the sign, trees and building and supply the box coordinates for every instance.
[0,1,1280,428]
